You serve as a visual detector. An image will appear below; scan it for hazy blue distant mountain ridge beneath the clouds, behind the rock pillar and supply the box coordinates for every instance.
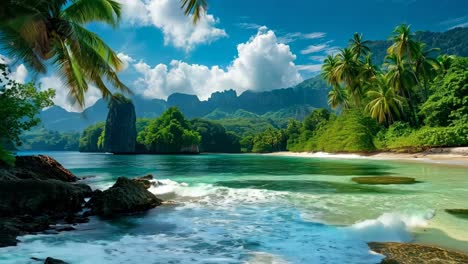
[40,76,330,132]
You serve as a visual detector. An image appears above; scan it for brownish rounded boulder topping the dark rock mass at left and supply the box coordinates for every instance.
[12,155,78,182]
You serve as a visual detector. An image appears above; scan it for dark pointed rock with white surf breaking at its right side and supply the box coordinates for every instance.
[87,177,162,217]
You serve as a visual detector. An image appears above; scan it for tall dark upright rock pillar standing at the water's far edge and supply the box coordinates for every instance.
[104,95,137,154]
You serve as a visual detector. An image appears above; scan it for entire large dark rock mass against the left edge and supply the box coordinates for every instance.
[0,155,92,247]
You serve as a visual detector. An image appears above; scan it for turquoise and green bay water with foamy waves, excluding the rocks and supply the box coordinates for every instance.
[0,152,468,263]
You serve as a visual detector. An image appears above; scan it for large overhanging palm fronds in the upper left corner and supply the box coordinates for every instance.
[0,0,130,106]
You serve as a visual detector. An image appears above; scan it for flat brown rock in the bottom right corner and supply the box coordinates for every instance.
[368,242,468,264]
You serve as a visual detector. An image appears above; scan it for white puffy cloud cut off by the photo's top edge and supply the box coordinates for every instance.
[121,0,227,51]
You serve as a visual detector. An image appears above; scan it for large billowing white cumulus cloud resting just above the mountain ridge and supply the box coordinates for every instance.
[134,27,302,99]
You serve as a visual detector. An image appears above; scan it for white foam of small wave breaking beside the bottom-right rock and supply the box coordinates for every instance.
[346,211,434,242]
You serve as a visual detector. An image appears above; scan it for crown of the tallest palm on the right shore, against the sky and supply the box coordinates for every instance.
[387,24,418,63]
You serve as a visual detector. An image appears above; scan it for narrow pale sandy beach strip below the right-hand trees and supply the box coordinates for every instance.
[263,147,468,167]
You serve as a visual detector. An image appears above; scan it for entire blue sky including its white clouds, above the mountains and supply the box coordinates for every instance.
[3,0,468,110]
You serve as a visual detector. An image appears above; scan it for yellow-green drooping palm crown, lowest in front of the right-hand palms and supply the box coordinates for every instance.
[365,74,405,125]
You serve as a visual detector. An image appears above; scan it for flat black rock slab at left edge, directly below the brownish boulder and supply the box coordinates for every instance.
[0,179,91,216]
